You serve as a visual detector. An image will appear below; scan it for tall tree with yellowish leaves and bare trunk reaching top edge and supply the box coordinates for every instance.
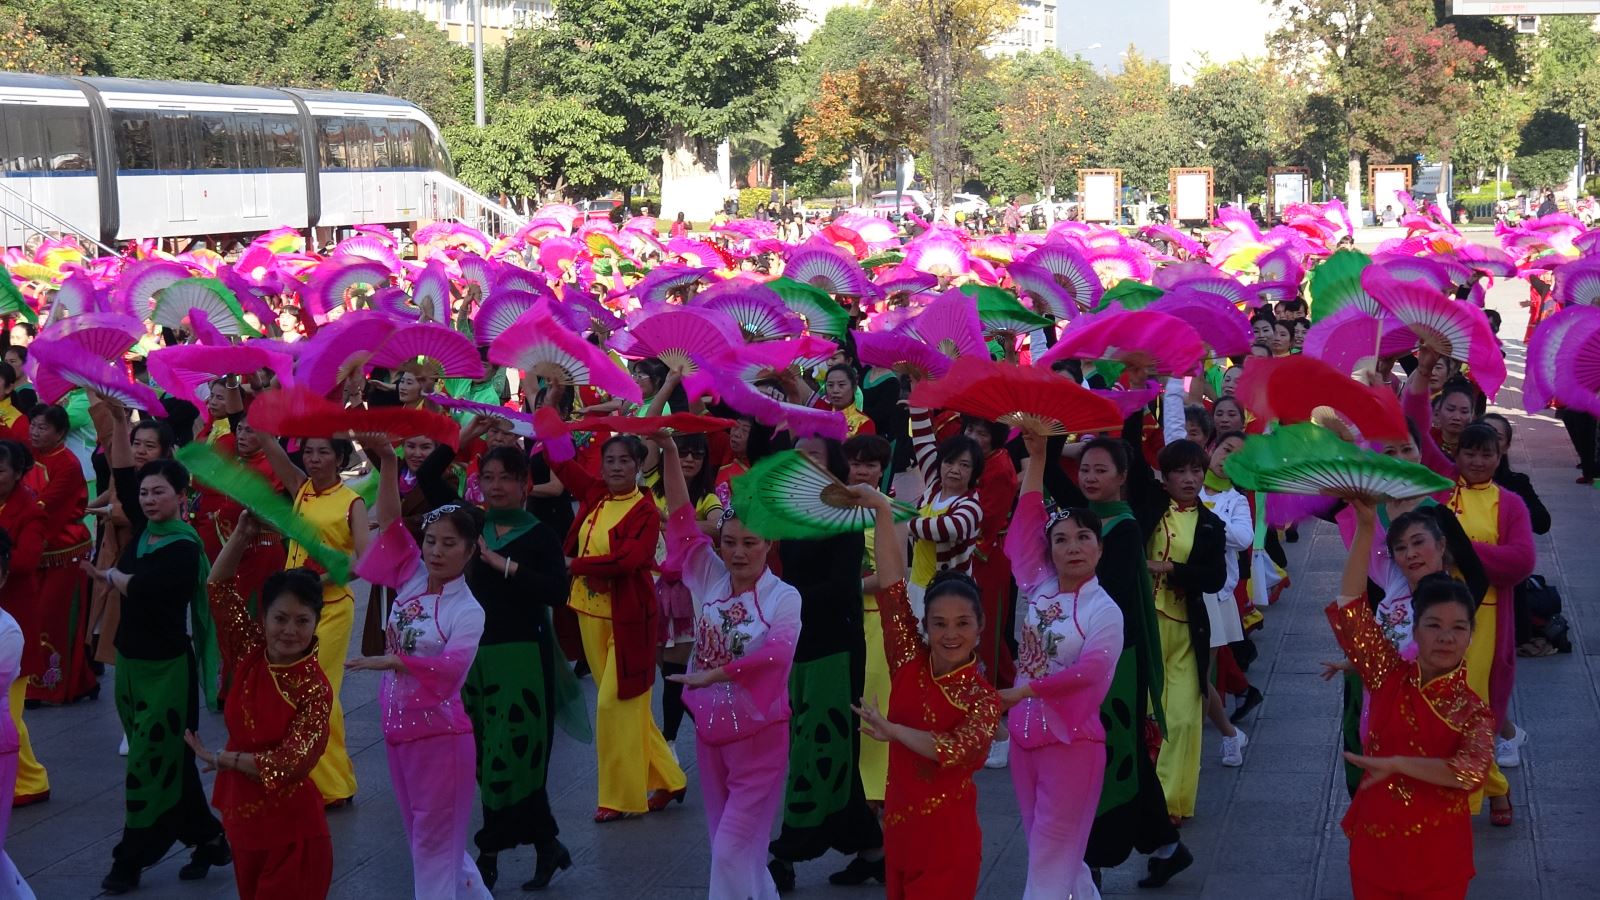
[883,0,1018,203]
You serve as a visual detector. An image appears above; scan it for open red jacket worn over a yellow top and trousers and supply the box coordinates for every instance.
[550,460,661,700]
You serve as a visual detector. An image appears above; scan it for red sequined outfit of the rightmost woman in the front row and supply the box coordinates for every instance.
[1326,602,1494,898]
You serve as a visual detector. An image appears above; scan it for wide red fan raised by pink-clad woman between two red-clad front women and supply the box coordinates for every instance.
[910,357,1126,434]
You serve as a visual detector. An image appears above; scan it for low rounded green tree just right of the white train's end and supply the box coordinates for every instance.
[445,98,645,203]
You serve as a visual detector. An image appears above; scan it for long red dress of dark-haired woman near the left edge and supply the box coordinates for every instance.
[22,445,96,703]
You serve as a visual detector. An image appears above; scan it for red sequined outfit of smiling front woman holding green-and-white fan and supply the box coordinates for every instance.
[878,581,1000,900]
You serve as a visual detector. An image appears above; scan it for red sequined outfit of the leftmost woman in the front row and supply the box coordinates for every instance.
[210,581,333,900]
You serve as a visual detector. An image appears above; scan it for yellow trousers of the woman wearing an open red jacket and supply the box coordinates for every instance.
[578,613,690,812]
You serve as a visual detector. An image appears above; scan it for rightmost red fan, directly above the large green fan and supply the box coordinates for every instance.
[1235,356,1410,440]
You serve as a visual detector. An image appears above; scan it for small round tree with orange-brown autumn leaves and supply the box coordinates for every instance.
[795,62,926,192]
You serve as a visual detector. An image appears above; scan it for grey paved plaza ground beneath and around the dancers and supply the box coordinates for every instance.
[6,235,1600,900]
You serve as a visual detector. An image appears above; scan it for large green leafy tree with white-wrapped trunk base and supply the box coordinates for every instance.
[506,0,797,218]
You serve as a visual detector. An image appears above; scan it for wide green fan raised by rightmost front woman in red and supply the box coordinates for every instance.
[1224,423,1454,501]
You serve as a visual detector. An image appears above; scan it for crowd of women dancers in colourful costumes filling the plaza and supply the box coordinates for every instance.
[0,190,1549,900]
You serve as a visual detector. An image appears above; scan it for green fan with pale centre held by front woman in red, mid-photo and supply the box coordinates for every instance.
[733,450,917,541]
